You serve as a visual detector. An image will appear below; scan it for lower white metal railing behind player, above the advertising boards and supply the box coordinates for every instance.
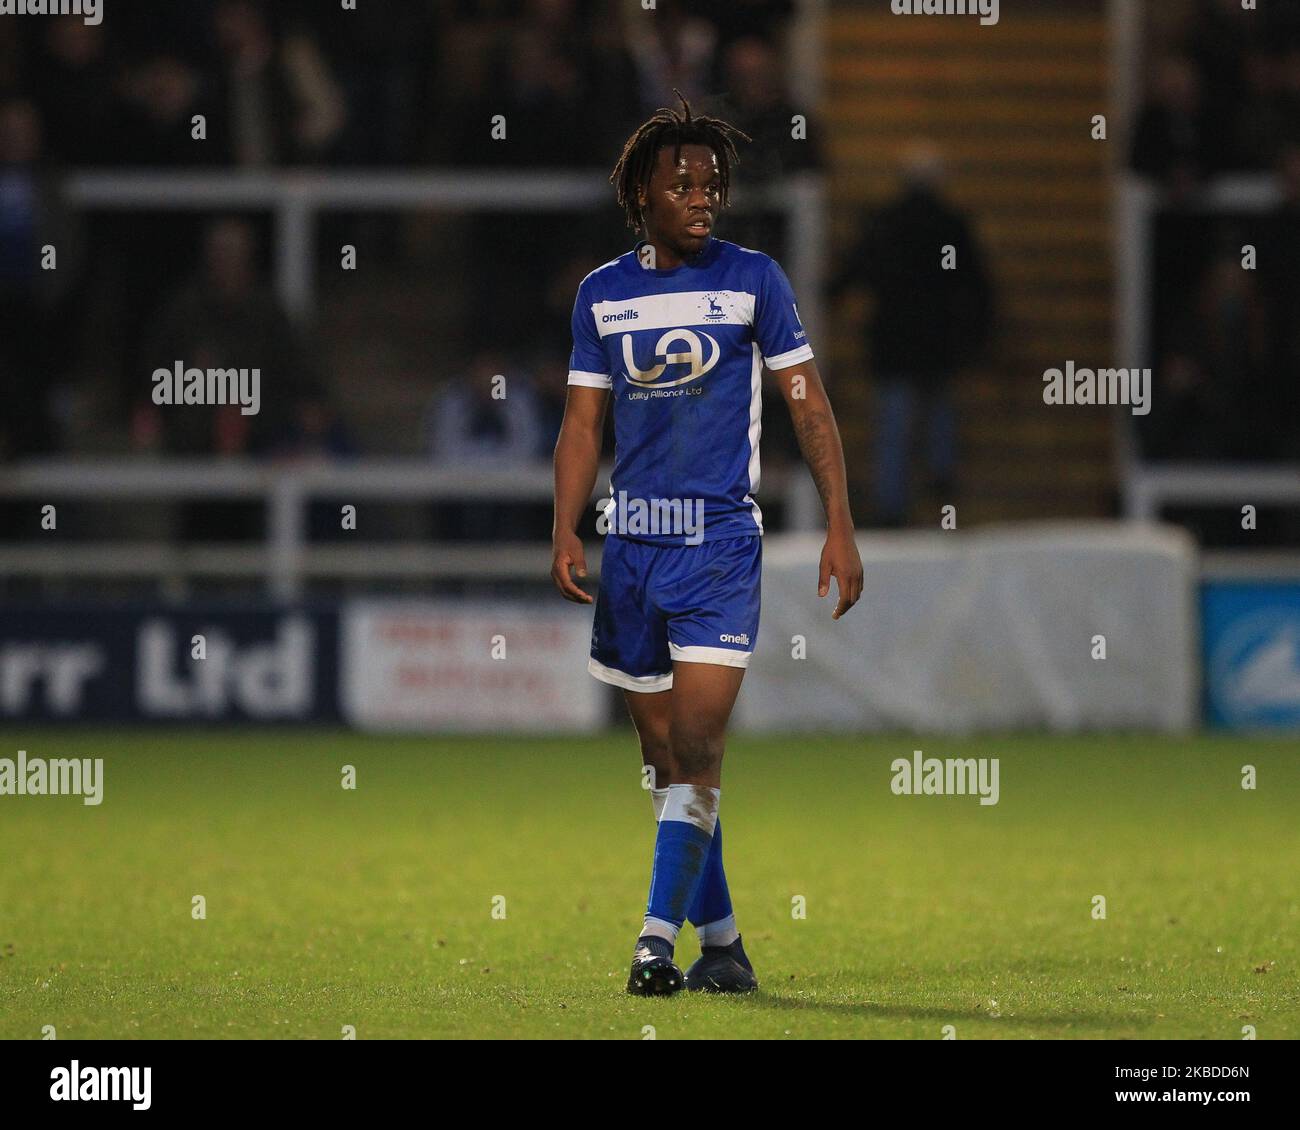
[0,459,820,601]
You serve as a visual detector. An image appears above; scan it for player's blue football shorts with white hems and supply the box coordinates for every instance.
[586,534,763,693]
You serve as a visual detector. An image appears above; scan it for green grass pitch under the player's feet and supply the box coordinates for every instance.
[0,728,1300,1039]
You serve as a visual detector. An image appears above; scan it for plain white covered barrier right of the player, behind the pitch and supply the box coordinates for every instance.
[736,523,1199,733]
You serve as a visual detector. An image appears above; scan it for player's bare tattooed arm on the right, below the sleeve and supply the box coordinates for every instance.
[772,360,862,620]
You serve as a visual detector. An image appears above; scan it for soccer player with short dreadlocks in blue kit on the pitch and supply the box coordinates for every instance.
[551,92,862,995]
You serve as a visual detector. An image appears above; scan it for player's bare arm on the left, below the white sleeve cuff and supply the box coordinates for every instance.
[551,385,610,605]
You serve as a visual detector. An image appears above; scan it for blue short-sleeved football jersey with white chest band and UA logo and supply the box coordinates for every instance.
[568,237,813,545]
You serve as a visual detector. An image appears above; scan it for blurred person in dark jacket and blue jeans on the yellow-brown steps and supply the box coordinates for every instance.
[829,143,992,527]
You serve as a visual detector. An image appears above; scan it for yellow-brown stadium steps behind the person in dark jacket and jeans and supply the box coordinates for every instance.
[823,0,1123,525]
